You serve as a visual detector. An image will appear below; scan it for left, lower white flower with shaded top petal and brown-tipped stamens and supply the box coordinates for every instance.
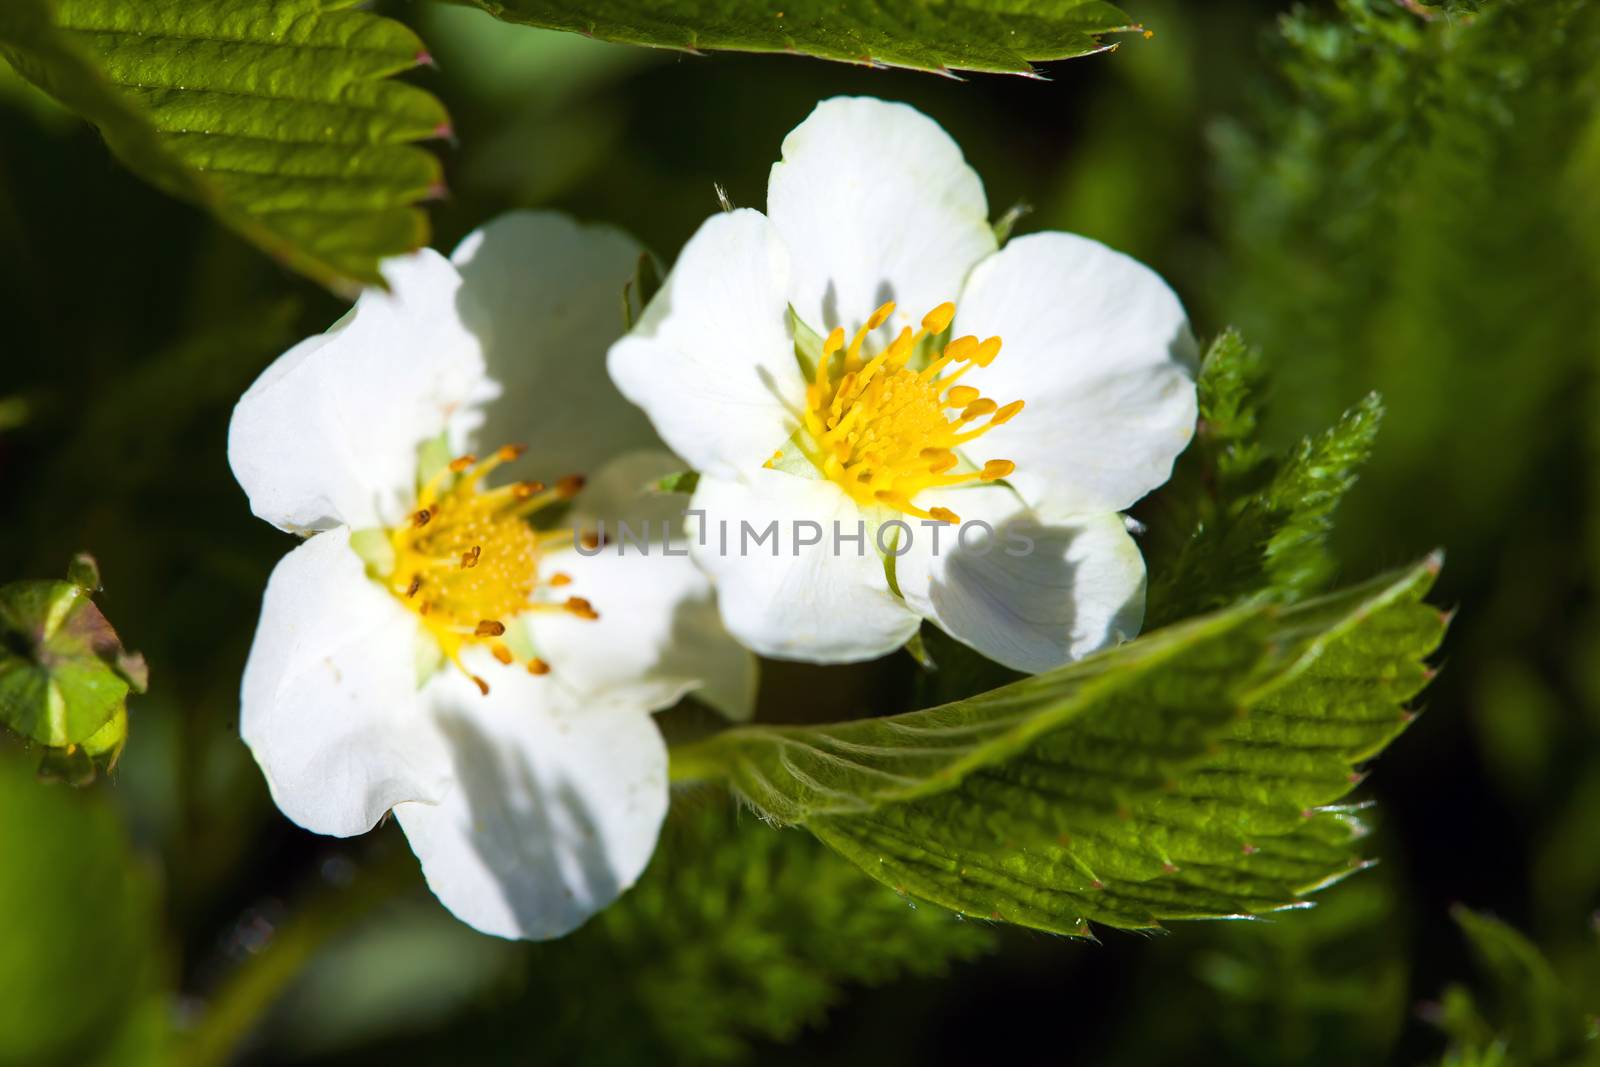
[229,214,754,937]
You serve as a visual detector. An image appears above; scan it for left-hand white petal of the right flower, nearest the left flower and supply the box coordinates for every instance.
[608,210,805,477]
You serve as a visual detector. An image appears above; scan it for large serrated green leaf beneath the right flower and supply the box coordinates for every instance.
[674,557,1445,934]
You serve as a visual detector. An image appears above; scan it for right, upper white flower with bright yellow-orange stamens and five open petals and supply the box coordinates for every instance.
[610,99,1195,670]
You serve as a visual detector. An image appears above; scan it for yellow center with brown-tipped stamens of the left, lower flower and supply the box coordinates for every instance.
[386,445,600,694]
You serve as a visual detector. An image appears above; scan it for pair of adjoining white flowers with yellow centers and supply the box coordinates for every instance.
[229,99,1195,937]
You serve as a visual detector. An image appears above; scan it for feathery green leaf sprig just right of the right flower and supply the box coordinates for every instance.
[1149,331,1382,624]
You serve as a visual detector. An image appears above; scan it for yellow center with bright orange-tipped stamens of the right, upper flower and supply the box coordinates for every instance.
[766,302,1022,523]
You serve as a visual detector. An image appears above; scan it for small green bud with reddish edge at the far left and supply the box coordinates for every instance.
[0,555,149,782]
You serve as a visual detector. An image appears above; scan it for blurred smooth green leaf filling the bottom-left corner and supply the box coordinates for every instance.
[0,752,166,1067]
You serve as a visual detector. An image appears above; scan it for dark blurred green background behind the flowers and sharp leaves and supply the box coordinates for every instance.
[0,0,1600,1067]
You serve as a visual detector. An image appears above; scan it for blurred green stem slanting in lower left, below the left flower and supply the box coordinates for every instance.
[178,849,410,1067]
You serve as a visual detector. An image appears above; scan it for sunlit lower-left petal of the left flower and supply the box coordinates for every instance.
[238,528,450,837]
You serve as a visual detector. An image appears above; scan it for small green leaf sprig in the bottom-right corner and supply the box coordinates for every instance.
[1435,907,1600,1067]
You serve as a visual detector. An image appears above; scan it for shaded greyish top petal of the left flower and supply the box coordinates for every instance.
[451,211,656,480]
